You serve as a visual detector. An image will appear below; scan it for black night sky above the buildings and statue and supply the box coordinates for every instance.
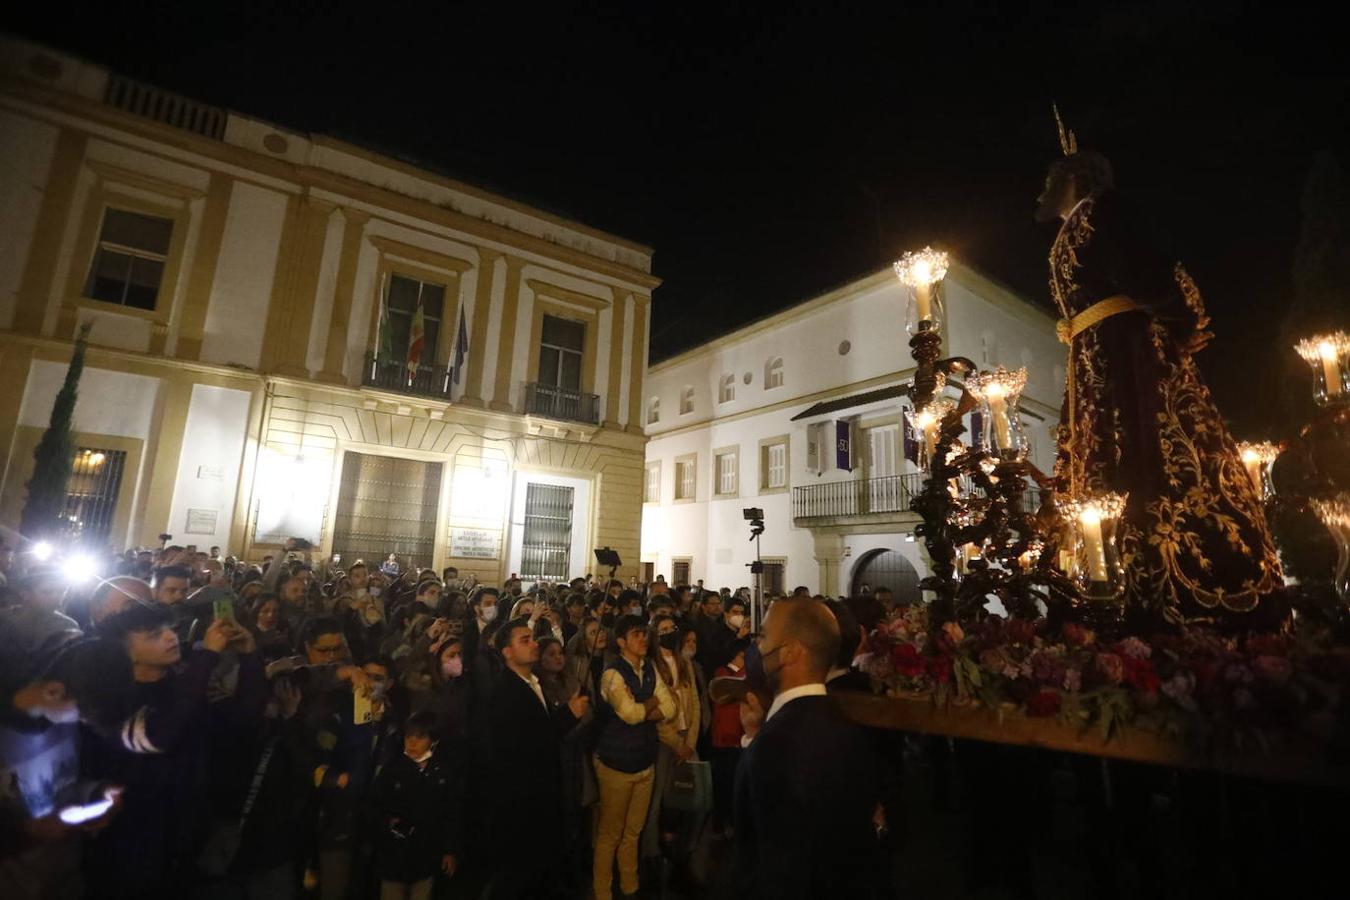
[0,3,1350,437]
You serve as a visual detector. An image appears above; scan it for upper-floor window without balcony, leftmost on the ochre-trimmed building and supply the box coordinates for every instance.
[85,208,173,310]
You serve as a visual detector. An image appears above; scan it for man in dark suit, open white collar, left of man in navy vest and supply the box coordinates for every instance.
[482,618,590,900]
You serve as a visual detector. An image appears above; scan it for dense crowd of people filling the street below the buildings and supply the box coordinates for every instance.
[0,545,895,900]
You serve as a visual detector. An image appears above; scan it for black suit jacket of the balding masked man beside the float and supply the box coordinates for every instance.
[736,696,879,900]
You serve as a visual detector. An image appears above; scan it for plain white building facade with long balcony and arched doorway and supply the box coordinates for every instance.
[643,263,1064,596]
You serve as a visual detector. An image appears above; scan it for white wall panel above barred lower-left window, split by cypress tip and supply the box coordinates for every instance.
[19,359,159,440]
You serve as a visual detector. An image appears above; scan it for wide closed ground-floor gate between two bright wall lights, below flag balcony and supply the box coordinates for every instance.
[333,452,441,569]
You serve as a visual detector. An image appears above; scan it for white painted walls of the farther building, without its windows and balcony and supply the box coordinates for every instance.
[641,267,1064,594]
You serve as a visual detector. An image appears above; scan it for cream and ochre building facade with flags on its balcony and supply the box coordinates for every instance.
[0,39,659,582]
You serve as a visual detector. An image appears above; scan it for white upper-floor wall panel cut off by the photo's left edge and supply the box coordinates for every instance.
[0,111,57,329]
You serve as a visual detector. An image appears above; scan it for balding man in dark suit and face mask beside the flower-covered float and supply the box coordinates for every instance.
[736,598,879,900]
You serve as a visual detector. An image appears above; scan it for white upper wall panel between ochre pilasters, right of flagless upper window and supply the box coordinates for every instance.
[201,181,290,368]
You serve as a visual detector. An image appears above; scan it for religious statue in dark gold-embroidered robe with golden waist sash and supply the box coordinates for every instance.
[1037,111,1283,623]
